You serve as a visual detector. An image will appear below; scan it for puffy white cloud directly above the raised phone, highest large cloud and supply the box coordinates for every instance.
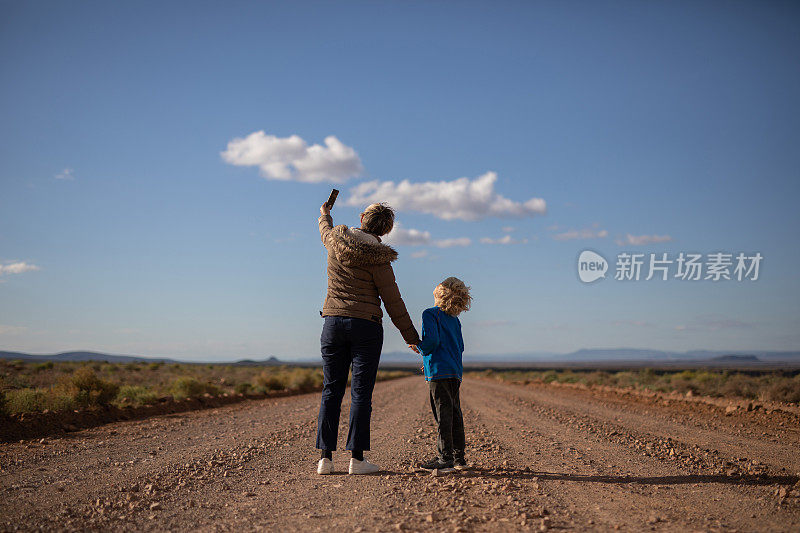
[220,130,364,183]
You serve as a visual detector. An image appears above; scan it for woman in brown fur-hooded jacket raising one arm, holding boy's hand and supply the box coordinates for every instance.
[317,204,420,474]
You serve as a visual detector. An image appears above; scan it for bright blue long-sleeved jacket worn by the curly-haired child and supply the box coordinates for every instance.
[417,307,464,381]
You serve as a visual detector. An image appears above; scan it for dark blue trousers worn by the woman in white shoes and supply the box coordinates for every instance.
[317,316,383,451]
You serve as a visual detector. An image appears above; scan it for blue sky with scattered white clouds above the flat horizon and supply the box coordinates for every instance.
[0,1,800,360]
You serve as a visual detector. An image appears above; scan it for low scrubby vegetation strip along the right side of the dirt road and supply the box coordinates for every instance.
[473,368,800,403]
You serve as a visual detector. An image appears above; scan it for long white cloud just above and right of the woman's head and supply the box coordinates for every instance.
[347,172,547,220]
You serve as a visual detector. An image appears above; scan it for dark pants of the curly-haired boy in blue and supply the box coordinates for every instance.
[430,378,465,462]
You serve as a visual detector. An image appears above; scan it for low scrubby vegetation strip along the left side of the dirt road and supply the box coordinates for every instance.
[0,359,408,414]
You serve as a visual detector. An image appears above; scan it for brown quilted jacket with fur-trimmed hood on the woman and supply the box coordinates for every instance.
[319,215,420,344]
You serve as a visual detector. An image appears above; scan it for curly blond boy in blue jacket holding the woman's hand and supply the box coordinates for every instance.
[411,277,472,472]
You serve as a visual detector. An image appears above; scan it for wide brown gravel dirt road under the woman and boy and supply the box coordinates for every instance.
[0,377,800,531]
